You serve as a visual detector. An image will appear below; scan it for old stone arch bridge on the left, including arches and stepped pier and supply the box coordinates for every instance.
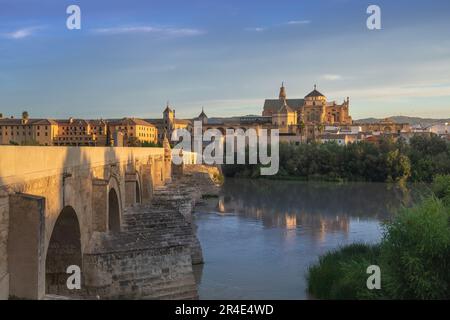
[0,146,207,299]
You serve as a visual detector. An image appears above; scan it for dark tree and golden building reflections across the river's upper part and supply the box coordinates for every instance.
[210,179,411,242]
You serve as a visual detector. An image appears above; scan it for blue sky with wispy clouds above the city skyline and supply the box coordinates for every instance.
[0,0,450,119]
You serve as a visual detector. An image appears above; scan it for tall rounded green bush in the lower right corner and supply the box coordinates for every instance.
[381,197,450,299]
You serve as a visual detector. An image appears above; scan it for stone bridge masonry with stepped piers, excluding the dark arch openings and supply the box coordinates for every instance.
[0,146,214,299]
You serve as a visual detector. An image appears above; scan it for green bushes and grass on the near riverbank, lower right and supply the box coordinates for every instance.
[307,175,450,299]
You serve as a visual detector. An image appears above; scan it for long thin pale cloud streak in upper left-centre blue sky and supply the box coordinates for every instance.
[93,26,205,37]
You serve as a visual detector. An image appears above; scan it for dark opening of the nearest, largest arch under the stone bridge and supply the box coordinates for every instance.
[45,206,83,295]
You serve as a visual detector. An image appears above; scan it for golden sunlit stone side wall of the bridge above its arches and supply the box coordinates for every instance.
[0,146,171,299]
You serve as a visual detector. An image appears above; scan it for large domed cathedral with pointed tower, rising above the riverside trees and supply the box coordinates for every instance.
[262,84,352,127]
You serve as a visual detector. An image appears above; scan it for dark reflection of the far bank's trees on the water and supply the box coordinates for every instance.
[219,179,411,220]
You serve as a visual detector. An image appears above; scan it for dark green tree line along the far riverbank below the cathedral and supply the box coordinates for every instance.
[223,135,450,182]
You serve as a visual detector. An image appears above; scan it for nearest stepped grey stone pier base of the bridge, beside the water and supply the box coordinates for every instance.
[83,205,198,299]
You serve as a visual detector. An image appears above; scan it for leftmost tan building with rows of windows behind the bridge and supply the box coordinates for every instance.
[0,112,58,146]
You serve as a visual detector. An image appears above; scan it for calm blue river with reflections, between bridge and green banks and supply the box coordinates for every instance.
[195,179,422,299]
